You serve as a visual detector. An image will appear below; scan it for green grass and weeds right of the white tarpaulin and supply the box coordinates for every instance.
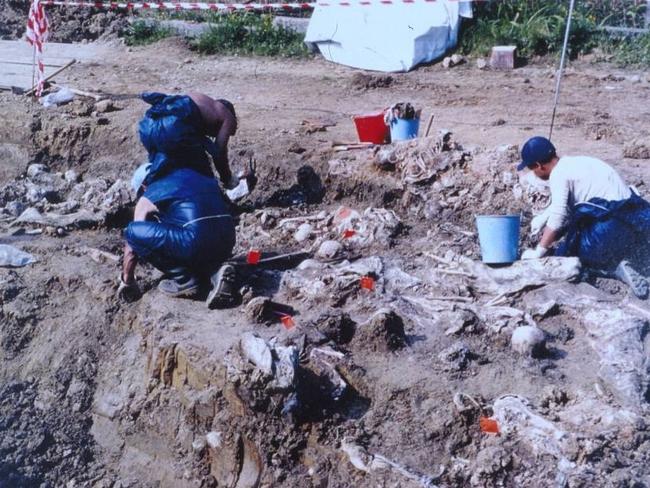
[460,0,650,66]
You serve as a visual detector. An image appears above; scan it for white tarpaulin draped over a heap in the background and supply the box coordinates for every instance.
[305,0,472,71]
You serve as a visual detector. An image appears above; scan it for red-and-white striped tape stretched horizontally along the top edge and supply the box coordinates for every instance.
[41,0,481,12]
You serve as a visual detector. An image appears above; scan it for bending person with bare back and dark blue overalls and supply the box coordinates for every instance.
[138,92,238,188]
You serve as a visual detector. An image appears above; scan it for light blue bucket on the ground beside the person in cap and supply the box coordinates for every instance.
[476,215,519,264]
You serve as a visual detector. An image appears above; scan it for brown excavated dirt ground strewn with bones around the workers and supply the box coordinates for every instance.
[0,10,650,488]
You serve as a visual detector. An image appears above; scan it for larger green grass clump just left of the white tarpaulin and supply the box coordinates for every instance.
[193,13,309,57]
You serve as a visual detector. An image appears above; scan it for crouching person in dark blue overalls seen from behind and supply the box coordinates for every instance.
[118,163,235,305]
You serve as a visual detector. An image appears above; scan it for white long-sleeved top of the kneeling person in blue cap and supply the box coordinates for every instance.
[546,156,632,230]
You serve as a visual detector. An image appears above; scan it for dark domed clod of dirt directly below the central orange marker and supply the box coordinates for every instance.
[353,308,406,352]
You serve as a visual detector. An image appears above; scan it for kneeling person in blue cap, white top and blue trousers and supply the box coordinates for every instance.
[517,137,650,298]
